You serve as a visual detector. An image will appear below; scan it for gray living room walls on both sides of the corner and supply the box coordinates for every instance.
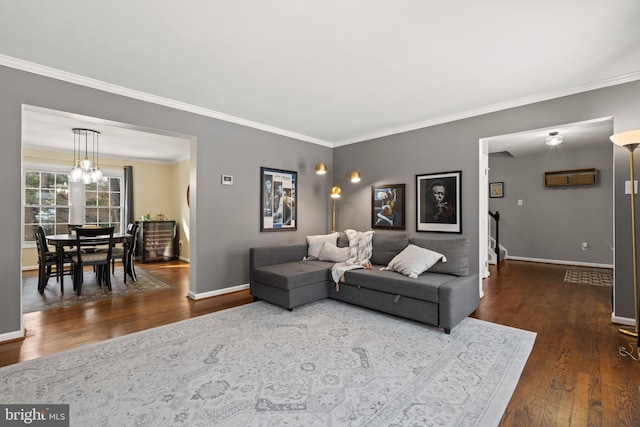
[0,67,640,338]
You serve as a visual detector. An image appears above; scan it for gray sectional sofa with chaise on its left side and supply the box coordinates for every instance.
[250,232,480,333]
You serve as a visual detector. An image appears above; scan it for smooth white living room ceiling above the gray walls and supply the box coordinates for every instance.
[0,0,640,159]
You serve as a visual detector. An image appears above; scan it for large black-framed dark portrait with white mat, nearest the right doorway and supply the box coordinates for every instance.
[416,171,462,233]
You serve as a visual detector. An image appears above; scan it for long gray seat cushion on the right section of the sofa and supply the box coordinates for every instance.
[344,266,456,303]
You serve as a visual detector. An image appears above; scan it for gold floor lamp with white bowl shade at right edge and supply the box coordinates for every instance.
[610,130,640,346]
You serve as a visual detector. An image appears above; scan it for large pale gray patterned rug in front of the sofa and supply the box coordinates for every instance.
[0,299,536,427]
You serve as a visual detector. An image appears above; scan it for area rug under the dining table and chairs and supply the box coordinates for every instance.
[22,268,173,313]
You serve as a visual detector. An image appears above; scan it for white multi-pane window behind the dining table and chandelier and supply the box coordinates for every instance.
[24,169,122,242]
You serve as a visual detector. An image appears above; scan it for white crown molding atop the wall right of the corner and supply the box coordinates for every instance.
[333,71,640,148]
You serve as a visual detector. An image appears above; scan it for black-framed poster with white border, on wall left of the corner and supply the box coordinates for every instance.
[260,167,298,231]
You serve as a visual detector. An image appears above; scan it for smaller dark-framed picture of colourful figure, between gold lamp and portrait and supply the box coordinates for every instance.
[371,184,405,230]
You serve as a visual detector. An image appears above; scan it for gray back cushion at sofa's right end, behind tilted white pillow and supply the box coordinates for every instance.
[411,237,469,276]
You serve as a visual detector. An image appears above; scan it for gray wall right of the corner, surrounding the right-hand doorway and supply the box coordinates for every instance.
[333,81,640,319]
